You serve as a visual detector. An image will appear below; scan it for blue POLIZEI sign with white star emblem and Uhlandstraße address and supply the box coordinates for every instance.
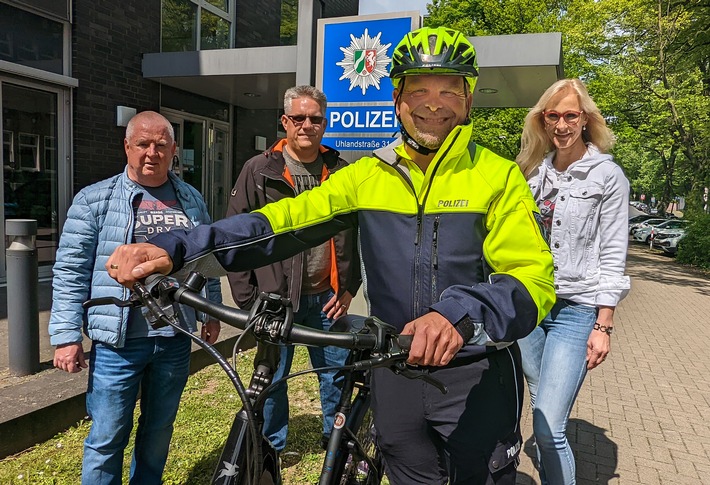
[316,12,421,151]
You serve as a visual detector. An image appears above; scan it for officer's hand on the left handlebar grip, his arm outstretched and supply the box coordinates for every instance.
[106,243,173,288]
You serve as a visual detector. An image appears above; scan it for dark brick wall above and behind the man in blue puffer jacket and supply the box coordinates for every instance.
[72,0,160,191]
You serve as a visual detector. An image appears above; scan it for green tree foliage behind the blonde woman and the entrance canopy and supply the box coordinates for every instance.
[427,0,710,264]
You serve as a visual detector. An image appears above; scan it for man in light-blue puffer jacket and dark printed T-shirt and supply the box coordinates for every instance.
[49,111,222,485]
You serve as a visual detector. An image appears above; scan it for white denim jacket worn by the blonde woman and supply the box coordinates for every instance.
[528,145,631,306]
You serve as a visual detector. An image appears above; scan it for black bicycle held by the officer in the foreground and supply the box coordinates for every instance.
[84,272,446,485]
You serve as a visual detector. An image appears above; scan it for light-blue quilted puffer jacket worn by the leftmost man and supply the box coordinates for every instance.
[49,170,222,347]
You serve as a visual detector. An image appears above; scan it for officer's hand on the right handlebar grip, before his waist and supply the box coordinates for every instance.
[402,312,464,366]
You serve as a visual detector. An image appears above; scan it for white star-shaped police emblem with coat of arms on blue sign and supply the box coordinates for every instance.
[335,29,392,94]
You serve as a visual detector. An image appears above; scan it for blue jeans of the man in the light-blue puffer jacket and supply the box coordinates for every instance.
[81,335,190,485]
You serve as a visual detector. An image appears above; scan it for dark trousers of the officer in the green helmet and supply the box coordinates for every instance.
[372,344,523,485]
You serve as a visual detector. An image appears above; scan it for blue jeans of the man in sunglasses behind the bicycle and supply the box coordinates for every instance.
[264,291,348,451]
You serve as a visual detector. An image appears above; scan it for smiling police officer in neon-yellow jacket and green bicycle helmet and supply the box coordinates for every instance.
[107,28,555,485]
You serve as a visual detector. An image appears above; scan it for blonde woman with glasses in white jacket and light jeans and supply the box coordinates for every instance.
[516,79,630,485]
